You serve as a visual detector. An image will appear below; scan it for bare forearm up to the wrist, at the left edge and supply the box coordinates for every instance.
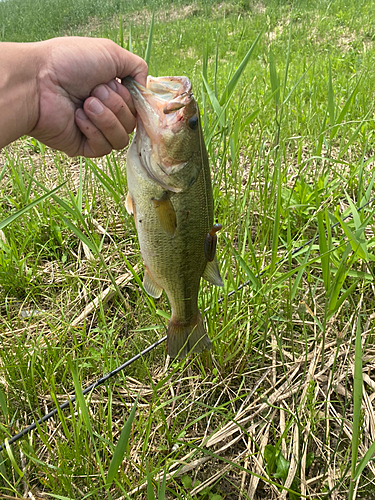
[0,42,41,148]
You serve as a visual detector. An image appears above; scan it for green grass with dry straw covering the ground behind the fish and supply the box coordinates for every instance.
[0,0,375,500]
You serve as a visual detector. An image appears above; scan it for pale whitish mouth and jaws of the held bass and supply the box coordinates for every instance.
[122,76,196,142]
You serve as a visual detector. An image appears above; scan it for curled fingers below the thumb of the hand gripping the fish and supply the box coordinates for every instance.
[75,80,135,158]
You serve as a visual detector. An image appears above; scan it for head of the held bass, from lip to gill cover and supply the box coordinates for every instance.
[122,76,206,192]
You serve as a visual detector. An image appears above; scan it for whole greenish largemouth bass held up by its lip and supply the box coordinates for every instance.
[122,76,223,359]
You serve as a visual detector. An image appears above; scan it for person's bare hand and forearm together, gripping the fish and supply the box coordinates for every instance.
[0,37,147,158]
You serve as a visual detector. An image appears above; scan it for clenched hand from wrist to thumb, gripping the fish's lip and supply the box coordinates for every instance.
[28,37,147,158]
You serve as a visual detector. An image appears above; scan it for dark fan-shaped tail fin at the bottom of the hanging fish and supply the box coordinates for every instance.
[167,312,211,359]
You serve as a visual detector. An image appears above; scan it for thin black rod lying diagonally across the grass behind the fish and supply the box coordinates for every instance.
[0,197,375,451]
